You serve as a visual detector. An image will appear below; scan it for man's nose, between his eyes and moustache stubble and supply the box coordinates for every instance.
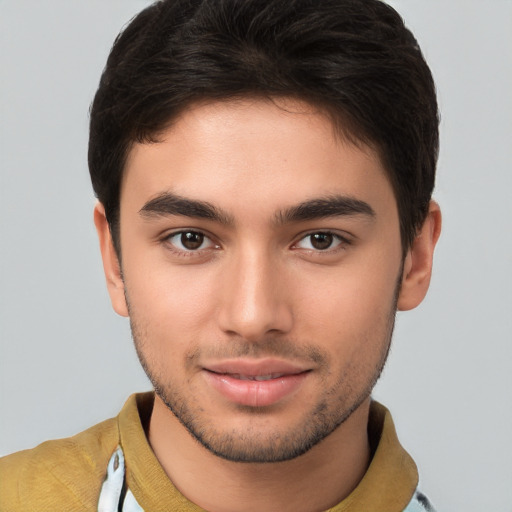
[218,247,293,342]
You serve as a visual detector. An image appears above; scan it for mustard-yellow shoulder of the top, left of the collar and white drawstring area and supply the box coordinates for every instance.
[0,419,119,512]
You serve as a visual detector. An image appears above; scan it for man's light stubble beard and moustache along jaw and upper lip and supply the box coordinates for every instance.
[126,269,402,463]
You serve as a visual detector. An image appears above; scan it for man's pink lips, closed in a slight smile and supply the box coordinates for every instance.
[203,359,310,407]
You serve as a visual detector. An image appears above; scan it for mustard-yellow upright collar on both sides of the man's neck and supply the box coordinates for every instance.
[117,393,418,512]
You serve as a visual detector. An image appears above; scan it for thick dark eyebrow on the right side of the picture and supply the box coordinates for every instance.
[276,195,376,224]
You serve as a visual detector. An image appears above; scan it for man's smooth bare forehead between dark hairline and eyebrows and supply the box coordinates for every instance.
[121,99,393,218]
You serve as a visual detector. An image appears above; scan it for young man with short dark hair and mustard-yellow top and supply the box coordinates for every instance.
[0,0,441,512]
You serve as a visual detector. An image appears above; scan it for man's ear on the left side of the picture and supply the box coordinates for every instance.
[94,202,129,316]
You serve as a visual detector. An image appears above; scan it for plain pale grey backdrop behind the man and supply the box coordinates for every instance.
[0,0,512,512]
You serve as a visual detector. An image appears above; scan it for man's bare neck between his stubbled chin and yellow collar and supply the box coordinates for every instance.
[149,396,370,512]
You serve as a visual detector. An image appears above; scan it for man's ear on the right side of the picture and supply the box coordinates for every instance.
[398,201,441,311]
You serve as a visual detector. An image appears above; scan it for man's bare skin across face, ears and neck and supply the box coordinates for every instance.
[95,99,441,512]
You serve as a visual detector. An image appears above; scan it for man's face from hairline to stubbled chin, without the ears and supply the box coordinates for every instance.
[113,100,402,462]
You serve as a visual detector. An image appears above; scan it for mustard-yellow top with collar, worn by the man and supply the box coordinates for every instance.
[0,393,418,512]
